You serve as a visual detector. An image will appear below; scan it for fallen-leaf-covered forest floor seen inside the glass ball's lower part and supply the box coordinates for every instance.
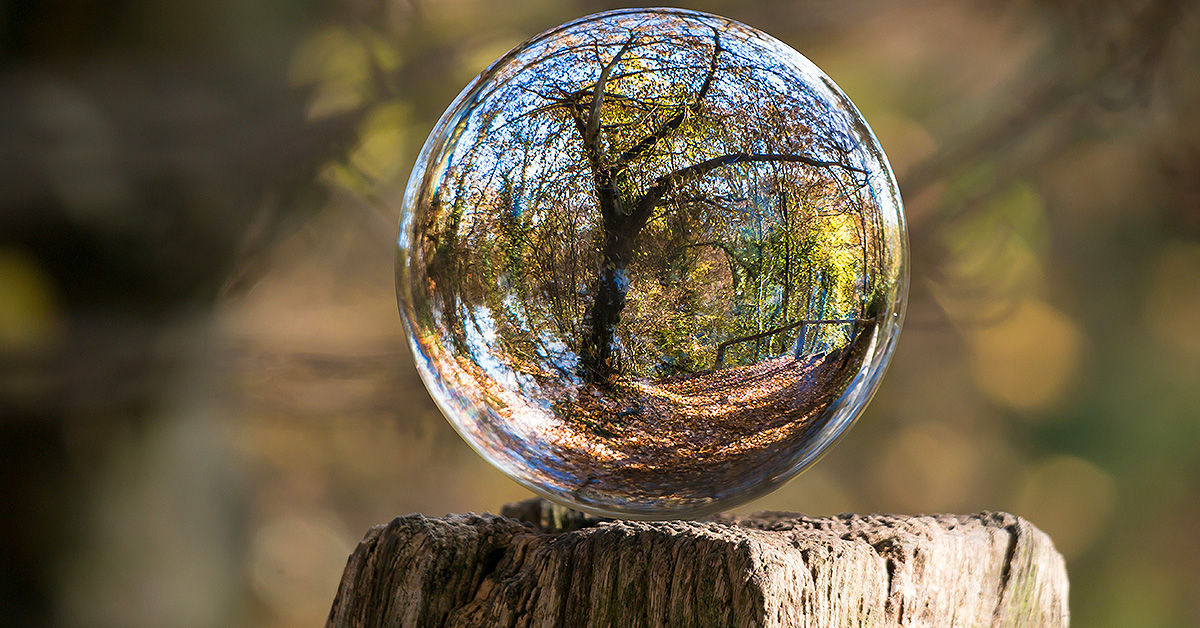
[434,328,874,510]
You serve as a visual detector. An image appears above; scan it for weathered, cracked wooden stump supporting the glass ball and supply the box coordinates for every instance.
[326,500,1068,628]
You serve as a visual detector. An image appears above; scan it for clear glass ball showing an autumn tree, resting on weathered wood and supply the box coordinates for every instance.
[396,8,907,519]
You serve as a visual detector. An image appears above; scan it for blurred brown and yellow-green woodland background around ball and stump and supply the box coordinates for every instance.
[0,0,1200,628]
